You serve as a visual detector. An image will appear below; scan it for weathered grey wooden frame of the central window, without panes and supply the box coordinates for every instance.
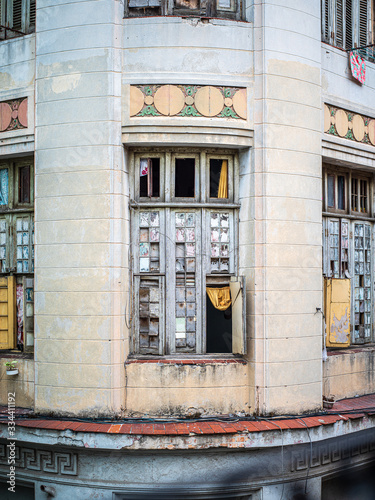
[129,148,246,356]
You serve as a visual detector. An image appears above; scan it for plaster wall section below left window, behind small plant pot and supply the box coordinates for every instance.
[0,358,34,408]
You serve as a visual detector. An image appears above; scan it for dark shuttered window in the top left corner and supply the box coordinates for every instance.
[0,0,36,40]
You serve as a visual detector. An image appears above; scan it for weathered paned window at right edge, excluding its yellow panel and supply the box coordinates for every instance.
[323,167,374,343]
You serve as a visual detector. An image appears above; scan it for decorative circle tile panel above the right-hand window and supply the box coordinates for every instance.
[324,104,375,146]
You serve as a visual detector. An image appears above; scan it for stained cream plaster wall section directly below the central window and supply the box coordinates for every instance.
[125,361,251,417]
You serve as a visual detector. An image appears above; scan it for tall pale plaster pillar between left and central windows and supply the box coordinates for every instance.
[35,0,129,417]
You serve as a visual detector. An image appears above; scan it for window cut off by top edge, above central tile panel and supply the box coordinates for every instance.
[125,0,242,19]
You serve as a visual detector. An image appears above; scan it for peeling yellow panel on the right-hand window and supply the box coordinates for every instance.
[324,278,350,347]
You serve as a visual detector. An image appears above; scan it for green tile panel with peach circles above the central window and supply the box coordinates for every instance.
[130,85,247,120]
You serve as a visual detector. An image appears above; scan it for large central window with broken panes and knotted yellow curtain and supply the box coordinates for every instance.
[132,151,244,355]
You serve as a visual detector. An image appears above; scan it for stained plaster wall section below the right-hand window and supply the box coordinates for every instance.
[323,347,375,400]
